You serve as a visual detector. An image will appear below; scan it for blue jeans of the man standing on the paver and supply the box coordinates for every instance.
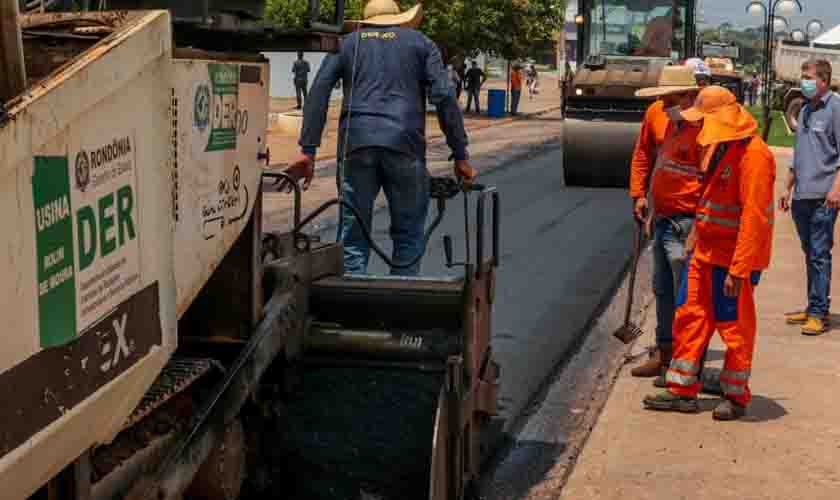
[339,147,429,276]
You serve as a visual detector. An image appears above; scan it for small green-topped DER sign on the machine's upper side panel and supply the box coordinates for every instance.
[207,64,239,151]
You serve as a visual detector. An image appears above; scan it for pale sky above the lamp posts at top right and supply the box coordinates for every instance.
[698,0,840,30]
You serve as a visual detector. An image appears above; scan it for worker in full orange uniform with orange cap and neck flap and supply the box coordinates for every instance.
[643,86,776,420]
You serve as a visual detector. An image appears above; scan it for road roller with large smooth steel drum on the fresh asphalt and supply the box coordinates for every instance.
[563,0,696,188]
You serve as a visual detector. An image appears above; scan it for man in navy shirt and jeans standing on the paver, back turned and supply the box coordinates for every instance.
[286,0,477,275]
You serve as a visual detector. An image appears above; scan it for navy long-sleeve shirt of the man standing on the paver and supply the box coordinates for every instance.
[299,27,468,160]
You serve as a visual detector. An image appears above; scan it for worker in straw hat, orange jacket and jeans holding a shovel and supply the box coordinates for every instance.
[630,64,708,387]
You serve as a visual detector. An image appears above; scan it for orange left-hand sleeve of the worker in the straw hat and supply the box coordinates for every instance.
[630,101,671,198]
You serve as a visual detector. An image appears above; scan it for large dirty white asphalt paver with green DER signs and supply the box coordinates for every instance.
[0,1,499,500]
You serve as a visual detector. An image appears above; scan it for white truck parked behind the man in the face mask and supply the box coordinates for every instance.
[772,40,840,131]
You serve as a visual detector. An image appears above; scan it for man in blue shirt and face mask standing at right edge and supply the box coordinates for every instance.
[779,59,840,335]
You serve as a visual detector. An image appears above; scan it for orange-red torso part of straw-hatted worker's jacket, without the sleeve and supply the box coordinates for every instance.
[650,122,703,217]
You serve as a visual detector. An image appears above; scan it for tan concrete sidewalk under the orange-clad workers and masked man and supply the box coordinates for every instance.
[554,149,840,500]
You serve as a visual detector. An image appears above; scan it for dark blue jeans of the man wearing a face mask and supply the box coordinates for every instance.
[791,200,837,318]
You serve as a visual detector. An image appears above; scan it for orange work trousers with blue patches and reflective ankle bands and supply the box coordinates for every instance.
[665,259,760,406]
